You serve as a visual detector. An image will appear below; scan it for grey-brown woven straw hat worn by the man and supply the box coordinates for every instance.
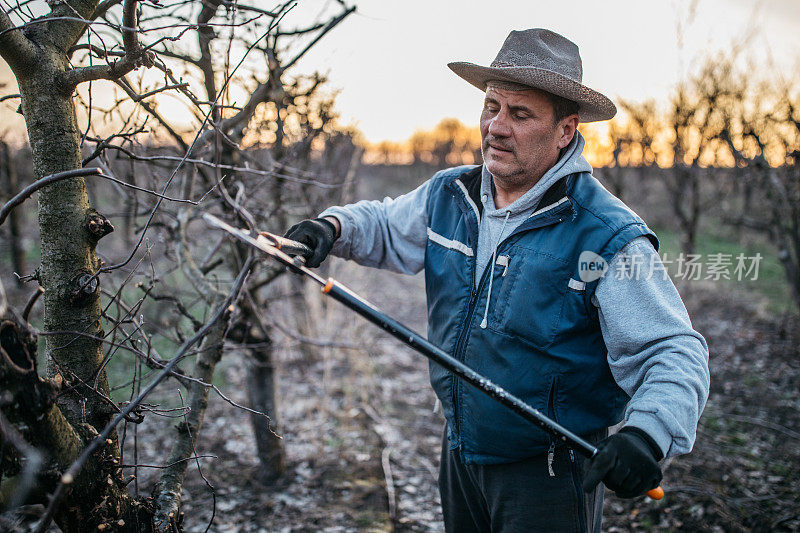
[447,28,617,122]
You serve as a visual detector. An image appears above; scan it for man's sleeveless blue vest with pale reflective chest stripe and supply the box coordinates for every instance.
[425,167,658,464]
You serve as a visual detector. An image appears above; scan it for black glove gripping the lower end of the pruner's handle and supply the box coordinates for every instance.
[583,427,663,498]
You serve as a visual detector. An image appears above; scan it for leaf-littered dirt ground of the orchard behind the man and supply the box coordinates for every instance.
[117,255,800,532]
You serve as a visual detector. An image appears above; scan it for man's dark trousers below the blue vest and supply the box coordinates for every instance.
[439,431,605,533]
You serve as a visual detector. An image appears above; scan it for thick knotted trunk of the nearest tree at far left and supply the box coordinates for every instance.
[11,39,146,533]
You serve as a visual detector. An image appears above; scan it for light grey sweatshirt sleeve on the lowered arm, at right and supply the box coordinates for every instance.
[592,237,710,457]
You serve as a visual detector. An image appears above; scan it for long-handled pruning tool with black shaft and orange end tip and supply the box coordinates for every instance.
[203,214,664,500]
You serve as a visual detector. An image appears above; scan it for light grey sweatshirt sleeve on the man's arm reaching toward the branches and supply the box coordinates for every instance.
[319,180,431,274]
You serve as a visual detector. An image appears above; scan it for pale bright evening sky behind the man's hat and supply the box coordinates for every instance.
[0,0,800,142]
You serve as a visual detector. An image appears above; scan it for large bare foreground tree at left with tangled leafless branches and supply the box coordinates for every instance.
[0,0,354,533]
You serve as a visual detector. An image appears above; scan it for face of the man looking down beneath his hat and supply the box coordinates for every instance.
[481,86,577,190]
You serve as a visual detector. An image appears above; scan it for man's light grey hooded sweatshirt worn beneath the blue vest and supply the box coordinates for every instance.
[320,133,709,457]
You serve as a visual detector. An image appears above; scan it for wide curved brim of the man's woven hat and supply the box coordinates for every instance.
[447,61,617,122]
